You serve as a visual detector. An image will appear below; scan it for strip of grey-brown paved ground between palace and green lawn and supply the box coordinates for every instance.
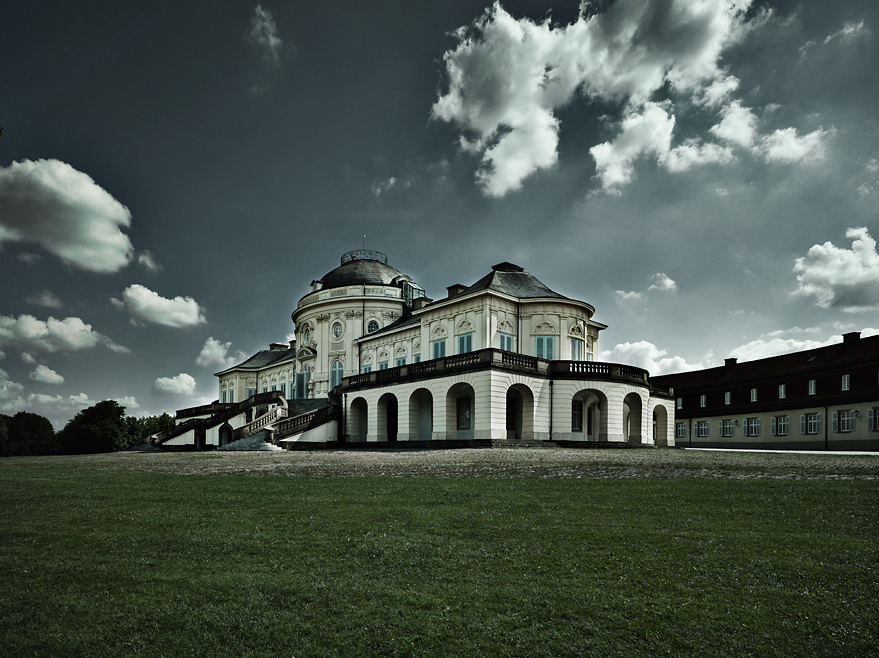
[0,448,879,480]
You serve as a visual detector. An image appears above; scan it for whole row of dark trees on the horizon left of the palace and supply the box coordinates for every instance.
[0,400,174,457]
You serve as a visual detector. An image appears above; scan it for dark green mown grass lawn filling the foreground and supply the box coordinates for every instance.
[0,467,879,658]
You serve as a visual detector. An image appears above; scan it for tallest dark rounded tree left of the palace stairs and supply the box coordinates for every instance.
[58,400,131,454]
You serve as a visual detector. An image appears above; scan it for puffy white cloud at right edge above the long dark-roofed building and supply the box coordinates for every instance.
[793,227,879,313]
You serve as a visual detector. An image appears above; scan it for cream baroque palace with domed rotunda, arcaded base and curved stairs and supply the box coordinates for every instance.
[160,250,674,449]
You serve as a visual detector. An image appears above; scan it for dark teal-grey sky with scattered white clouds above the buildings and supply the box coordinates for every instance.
[0,0,879,427]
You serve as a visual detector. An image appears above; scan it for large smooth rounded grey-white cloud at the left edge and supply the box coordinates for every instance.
[0,160,133,273]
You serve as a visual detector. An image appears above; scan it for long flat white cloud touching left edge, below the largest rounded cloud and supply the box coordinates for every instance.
[0,314,130,353]
